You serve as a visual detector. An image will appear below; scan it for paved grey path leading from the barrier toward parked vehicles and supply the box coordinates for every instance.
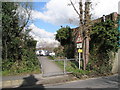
[38,56,63,76]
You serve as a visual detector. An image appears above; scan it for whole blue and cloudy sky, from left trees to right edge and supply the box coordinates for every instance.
[29,0,120,47]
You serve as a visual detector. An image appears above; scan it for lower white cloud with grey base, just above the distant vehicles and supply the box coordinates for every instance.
[29,24,59,48]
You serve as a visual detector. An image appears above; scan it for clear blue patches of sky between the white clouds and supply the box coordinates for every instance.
[30,2,76,33]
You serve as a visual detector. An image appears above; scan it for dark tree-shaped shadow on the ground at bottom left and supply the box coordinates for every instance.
[2,75,44,90]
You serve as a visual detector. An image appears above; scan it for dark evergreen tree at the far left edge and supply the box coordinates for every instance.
[2,2,18,60]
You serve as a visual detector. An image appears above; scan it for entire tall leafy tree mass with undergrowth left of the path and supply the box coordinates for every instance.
[2,2,39,74]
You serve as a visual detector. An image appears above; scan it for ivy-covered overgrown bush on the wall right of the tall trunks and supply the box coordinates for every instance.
[87,20,119,74]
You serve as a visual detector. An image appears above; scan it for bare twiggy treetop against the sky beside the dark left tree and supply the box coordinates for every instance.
[16,2,32,34]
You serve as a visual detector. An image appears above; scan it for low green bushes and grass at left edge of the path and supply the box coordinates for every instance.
[2,47,40,75]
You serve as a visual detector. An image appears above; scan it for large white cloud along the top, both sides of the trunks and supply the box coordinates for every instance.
[32,0,119,25]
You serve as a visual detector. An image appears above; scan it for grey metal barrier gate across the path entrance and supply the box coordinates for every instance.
[41,56,78,76]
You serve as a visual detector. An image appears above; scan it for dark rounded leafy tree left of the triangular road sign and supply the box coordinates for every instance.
[56,26,75,58]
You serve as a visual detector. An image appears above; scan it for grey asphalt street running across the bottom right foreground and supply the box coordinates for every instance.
[16,74,120,90]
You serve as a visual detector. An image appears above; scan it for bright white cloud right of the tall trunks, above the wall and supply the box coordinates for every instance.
[92,0,120,17]
